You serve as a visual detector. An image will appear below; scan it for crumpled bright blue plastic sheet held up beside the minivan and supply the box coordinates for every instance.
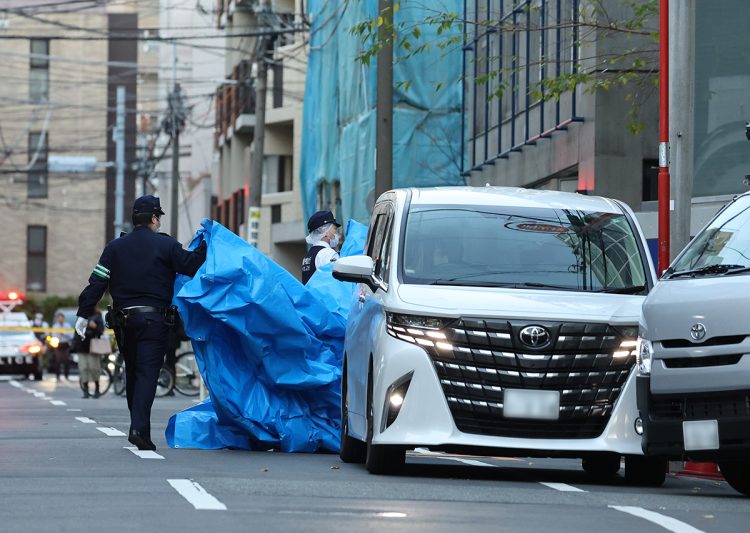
[166,220,367,452]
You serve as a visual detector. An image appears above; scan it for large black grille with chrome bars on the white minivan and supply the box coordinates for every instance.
[389,318,635,439]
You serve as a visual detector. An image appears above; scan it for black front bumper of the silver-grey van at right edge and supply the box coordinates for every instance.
[636,376,750,461]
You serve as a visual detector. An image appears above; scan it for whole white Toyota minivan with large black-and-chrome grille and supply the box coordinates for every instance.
[333,187,666,485]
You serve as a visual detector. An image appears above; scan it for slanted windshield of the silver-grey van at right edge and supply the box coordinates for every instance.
[668,197,750,276]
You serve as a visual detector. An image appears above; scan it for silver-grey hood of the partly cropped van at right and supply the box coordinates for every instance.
[643,275,750,341]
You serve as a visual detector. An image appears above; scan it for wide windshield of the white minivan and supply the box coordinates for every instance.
[401,206,646,294]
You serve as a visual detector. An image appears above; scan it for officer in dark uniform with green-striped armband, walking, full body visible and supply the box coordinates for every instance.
[75,195,206,450]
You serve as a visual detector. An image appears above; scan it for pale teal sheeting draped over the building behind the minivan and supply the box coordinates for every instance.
[300,0,464,227]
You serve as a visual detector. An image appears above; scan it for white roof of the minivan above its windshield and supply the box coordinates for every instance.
[402,186,623,214]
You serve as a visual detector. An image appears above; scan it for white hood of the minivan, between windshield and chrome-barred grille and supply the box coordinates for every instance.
[398,285,645,324]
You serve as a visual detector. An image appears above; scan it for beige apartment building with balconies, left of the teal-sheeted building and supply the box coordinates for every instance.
[212,0,307,276]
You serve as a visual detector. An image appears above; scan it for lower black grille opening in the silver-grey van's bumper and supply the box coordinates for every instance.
[650,392,750,420]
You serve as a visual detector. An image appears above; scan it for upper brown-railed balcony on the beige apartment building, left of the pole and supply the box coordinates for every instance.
[214,60,255,147]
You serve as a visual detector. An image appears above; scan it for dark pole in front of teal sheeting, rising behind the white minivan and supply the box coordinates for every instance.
[374,0,393,200]
